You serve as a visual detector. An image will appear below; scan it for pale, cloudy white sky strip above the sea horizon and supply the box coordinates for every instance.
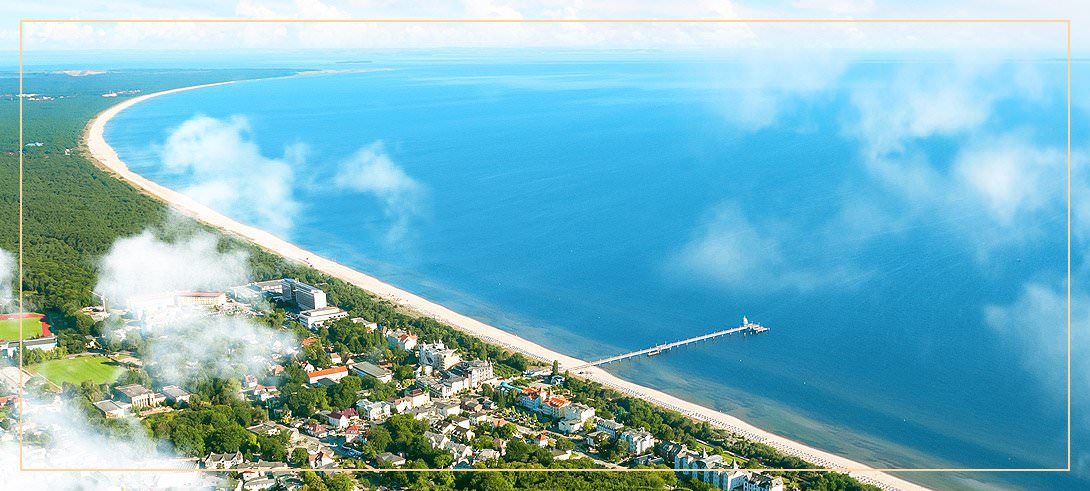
[0,0,1090,52]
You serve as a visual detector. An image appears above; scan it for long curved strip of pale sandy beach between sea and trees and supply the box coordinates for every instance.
[82,75,928,490]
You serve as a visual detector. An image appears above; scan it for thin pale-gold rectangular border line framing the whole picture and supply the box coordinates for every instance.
[19,19,1071,480]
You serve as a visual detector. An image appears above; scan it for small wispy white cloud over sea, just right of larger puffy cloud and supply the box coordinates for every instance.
[334,142,424,241]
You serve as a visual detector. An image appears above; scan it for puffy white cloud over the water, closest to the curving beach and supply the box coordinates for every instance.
[160,116,301,235]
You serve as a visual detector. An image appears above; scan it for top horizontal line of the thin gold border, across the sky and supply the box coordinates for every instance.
[22,19,1070,24]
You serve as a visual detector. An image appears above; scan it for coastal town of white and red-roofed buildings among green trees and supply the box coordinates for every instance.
[0,278,790,491]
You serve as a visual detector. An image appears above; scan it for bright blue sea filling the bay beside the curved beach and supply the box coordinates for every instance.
[106,52,1087,489]
